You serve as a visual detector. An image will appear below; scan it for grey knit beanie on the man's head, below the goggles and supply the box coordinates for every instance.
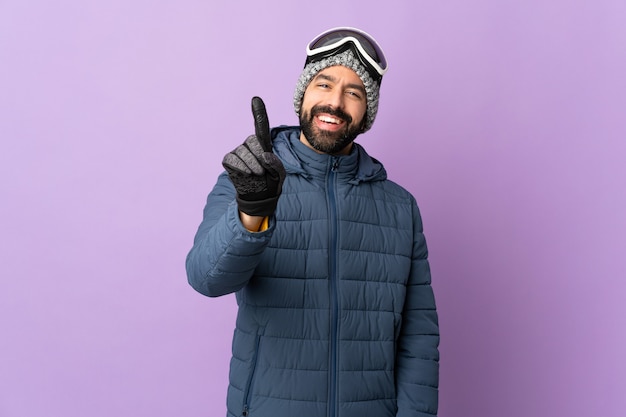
[293,49,380,132]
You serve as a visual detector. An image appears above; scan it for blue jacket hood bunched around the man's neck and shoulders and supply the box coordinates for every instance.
[271,126,387,184]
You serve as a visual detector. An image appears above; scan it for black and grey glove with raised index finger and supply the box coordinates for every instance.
[222,97,286,217]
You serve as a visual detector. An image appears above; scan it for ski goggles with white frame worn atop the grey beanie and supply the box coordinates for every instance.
[306,27,387,81]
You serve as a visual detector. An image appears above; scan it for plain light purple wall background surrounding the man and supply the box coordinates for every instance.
[0,0,626,417]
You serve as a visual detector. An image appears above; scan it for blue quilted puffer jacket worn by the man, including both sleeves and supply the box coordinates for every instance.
[187,127,439,417]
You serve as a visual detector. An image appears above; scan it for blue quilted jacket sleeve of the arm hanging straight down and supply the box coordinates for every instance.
[396,200,439,417]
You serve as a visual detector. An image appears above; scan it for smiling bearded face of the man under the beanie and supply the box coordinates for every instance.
[300,65,367,154]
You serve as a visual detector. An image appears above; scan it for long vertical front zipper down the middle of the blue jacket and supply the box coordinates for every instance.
[327,158,339,417]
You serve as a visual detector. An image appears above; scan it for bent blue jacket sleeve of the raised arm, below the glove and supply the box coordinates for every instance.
[185,172,274,297]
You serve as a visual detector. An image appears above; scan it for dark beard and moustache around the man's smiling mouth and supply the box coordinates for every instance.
[300,106,365,155]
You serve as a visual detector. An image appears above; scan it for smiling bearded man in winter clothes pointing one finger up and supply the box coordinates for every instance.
[187,28,439,417]
